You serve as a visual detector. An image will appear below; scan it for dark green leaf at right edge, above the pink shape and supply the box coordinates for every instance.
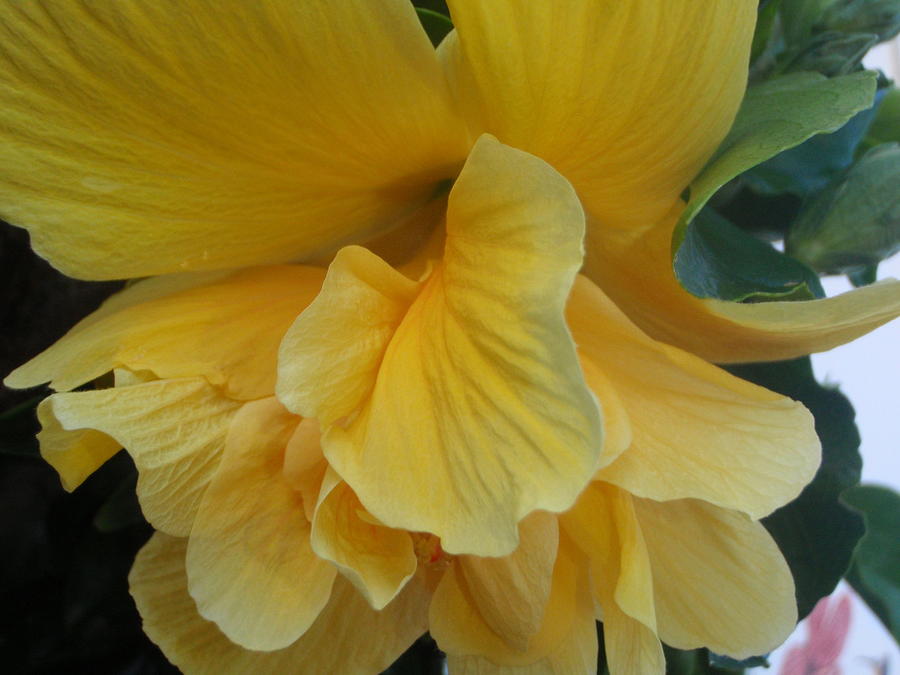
[842,485,900,642]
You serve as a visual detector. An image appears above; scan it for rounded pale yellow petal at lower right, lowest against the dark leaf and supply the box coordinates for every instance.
[634,499,797,659]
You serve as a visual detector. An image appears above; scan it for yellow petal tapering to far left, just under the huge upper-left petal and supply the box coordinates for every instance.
[6,266,324,399]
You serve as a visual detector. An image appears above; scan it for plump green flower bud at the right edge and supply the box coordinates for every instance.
[785,143,900,273]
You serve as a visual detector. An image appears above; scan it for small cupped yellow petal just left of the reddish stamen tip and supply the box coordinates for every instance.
[310,470,418,609]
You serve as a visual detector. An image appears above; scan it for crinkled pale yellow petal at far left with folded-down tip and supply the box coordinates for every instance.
[39,378,240,536]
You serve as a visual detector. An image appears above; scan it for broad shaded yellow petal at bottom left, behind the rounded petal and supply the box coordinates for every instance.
[129,533,428,675]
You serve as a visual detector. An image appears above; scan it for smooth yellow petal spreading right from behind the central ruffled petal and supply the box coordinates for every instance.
[568,277,820,517]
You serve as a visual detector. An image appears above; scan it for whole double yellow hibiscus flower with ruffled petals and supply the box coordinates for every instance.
[0,0,900,673]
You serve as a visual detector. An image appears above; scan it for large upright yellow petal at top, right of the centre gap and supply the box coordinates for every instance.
[440,0,757,232]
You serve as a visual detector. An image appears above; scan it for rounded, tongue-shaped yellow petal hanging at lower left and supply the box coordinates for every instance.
[186,397,336,651]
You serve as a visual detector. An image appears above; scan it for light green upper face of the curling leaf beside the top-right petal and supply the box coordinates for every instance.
[673,73,875,251]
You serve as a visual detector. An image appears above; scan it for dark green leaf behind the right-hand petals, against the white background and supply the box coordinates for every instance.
[728,358,864,618]
